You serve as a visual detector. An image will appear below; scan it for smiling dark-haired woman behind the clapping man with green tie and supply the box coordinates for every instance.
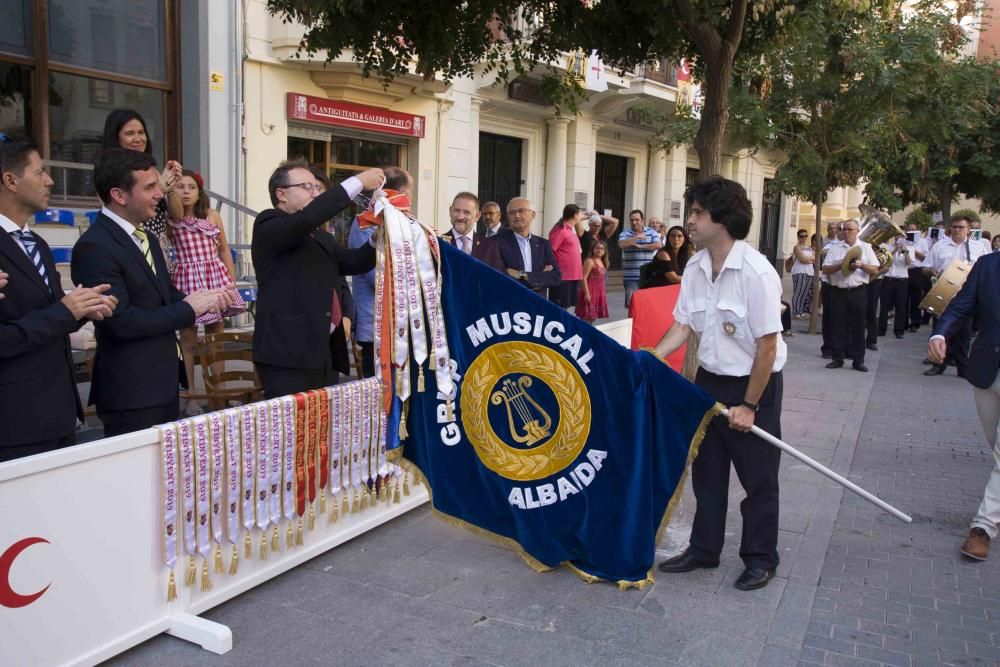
[101,109,184,270]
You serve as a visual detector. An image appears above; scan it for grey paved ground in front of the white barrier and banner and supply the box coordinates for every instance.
[113,310,1000,666]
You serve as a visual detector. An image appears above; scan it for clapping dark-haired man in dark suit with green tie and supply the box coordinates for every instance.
[72,148,232,437]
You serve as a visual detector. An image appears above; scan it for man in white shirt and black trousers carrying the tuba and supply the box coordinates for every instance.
[822,219,879,373]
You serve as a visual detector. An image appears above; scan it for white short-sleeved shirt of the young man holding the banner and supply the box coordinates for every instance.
[674,241,788,377]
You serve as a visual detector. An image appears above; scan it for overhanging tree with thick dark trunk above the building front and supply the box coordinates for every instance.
[267,0,804,176]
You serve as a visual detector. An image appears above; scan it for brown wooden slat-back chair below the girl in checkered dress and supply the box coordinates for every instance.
[187,332,262,410]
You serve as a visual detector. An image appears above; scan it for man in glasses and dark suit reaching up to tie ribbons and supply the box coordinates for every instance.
[251,162,385,397]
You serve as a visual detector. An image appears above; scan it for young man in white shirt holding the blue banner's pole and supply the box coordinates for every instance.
[656,177,787,590]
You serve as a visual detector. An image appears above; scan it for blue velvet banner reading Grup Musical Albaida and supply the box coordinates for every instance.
[403,243,715,585]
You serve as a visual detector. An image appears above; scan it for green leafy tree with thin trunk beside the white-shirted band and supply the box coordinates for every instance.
[733,2,938,333]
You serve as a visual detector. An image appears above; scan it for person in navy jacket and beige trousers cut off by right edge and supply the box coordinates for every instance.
[927,252,1000,560]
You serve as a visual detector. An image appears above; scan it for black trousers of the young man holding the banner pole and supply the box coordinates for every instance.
[691,368,784,569]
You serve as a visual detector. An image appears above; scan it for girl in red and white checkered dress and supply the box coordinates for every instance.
[168,169,246,389]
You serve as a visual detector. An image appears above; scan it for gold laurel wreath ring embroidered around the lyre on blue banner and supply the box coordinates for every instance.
[463,349,590,479]
